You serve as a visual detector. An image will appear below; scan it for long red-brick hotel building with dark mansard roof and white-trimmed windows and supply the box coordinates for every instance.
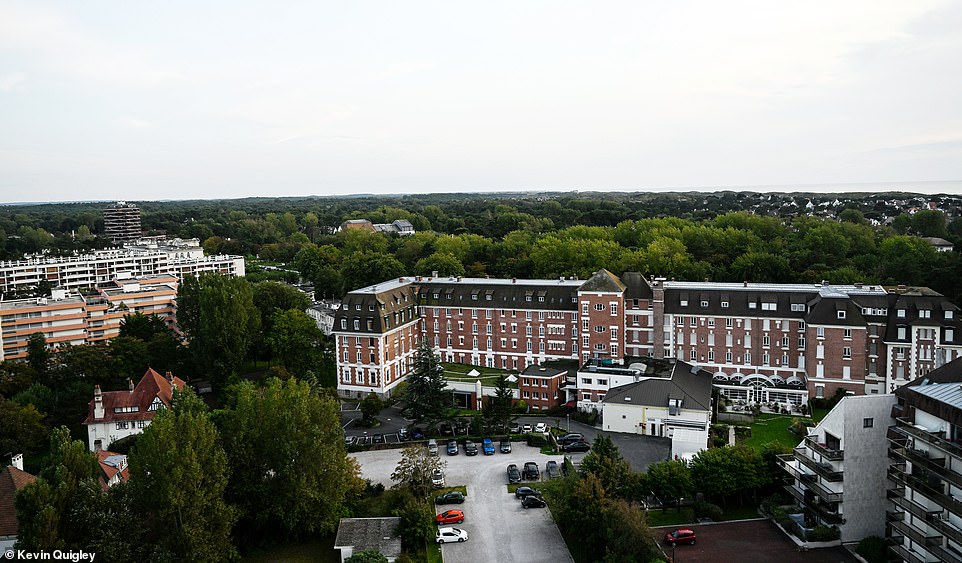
[333,270,962,404]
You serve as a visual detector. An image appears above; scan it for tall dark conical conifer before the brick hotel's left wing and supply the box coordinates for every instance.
[405,340,452,425]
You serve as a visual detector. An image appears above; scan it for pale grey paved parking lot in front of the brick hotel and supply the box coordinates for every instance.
[351,440,572,563]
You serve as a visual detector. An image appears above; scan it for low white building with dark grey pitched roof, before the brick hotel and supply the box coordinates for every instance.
[601,360,712,458]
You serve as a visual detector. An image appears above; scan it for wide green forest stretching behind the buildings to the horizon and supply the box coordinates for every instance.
[0,192,962,302]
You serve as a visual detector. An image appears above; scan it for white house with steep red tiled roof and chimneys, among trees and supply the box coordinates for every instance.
[84,369,187,452]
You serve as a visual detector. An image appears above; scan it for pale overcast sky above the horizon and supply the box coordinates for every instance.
[0,0,962,202]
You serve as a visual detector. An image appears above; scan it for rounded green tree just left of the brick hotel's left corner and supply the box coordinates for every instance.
[267,309,324,377]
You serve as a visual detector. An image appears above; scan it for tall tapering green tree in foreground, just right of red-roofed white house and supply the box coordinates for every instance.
[129,388,237,561]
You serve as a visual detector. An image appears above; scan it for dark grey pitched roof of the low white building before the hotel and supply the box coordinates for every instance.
[602,360,712,411]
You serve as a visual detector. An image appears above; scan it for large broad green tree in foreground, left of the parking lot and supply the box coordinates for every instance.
[218,379,361,537]
